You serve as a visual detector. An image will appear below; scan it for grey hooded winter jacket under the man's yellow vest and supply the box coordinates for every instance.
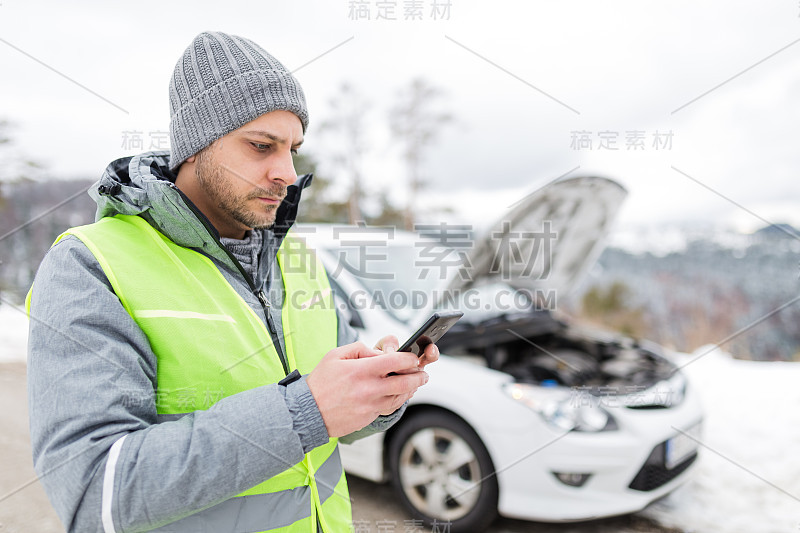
[28,152,403,533]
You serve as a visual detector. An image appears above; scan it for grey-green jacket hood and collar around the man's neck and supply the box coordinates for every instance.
[89,151,311,271]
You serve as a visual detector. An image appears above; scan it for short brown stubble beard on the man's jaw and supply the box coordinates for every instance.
[195,150,286,229]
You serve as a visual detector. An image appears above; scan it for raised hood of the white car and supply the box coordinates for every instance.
[445,177,628,294]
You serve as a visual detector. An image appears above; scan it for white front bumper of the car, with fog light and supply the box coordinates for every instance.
[487,382,702,522]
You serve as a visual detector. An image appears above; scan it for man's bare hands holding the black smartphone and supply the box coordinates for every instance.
[306,336,438,437]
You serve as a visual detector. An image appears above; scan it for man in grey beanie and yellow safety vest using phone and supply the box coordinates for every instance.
[28,32,438,533]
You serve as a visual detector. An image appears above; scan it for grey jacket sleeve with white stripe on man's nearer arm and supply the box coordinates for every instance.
[28,237,328,532]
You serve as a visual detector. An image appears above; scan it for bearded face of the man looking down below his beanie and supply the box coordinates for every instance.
[181,111,303,239]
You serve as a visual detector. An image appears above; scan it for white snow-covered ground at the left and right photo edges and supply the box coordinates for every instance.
[0,306,800,533]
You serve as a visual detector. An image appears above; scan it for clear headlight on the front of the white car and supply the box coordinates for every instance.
[504,383,617,432]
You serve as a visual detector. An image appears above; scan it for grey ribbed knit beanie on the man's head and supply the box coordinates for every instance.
[169,32,308,170]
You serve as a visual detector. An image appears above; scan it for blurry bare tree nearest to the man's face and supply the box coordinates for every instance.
[320,83,371,224]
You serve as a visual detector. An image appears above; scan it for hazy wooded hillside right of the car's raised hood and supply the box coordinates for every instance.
[571,224,800,360]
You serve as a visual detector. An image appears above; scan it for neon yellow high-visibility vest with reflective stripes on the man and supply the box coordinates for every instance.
[28,215,351,533]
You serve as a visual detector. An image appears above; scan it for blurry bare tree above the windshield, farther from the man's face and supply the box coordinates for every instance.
[389,78,452,230]
